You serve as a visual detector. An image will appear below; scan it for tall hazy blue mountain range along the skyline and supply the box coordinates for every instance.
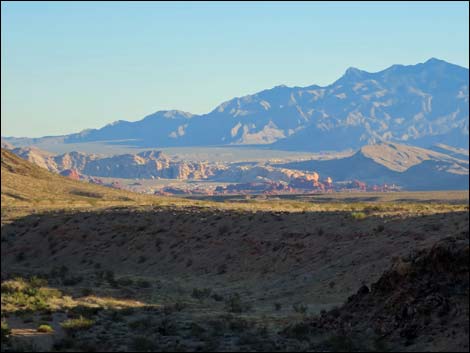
[5,58,469,151]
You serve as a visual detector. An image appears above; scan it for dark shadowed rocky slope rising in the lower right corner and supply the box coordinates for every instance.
[285,230,469,351]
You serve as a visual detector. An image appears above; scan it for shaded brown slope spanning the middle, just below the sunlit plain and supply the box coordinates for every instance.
[1,204,468,282]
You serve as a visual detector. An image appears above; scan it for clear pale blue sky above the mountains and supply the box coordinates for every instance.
[1,1,469,137]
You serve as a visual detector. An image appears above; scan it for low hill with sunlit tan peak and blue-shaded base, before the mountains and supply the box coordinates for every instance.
[279,143,469,190]
